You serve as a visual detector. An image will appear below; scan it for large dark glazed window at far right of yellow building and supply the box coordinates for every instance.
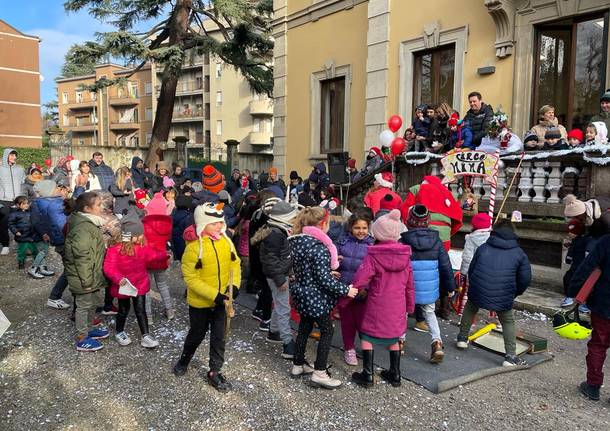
[530,14,608,129]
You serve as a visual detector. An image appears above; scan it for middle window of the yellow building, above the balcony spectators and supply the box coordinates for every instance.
[411,44,455,111]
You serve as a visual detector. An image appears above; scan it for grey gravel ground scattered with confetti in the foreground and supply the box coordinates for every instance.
[0,250,610,431]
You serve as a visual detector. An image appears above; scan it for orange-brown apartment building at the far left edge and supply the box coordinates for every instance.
[0,19,42,148]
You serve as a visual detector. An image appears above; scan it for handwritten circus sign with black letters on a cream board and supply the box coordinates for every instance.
[441,149,498,184]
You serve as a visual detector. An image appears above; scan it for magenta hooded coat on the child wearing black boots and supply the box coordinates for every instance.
[354,241,415,338]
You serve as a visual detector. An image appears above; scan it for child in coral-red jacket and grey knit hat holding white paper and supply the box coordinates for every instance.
[104,210,169,349]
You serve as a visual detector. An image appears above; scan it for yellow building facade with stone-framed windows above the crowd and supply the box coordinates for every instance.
[274,0,610,173]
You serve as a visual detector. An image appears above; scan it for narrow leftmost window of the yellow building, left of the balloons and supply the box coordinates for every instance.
[320,76,345,154]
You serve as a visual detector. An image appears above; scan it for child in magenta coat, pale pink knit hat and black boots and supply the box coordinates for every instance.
[352,210,415,387]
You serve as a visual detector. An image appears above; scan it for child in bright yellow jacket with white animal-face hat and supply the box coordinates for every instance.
[174,203,241,392]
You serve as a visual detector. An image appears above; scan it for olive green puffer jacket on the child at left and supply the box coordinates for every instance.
[64,213,107,295]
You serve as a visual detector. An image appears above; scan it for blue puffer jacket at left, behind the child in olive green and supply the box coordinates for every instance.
[30,196,68,246]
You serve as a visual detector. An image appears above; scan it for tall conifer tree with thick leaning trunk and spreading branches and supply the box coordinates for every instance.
[64,0,273,166]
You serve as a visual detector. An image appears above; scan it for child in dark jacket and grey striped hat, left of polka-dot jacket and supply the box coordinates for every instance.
[252,201,297,359]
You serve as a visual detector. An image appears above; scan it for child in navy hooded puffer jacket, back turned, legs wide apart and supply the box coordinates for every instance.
[457,219,532,367]
